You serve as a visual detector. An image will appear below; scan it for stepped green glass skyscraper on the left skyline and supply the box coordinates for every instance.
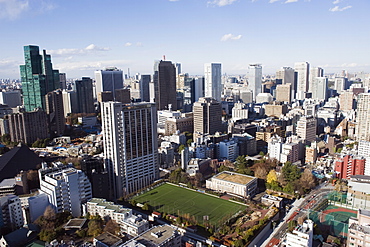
[20,45,60,111]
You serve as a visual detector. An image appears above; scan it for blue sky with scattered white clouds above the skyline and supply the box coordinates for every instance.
[0,0,370,78]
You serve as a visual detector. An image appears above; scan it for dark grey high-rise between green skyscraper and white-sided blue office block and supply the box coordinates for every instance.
[75,77,95,113]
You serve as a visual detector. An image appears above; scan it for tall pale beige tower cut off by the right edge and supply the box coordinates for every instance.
[355,93,370,141]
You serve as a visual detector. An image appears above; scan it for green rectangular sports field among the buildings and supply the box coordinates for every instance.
[133,184,246,225]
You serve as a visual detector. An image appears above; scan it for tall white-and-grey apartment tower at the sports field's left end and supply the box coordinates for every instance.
[101,102,159,198]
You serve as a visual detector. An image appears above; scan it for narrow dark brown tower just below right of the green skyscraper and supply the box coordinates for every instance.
[45,89,66,137]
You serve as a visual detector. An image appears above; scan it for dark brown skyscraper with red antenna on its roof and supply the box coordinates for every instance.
[153,60,177,110]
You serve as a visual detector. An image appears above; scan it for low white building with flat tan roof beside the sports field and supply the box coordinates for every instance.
[206,171,257,198]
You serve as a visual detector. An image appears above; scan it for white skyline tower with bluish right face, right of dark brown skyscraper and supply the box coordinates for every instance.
[204,63,222,102]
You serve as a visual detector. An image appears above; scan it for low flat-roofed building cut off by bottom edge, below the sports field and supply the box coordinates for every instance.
[119,225,181,247]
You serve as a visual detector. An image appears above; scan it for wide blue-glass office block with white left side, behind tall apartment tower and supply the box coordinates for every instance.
[95,67,123,98]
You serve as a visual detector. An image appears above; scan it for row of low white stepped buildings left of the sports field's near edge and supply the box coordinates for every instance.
[86,198,149,236]
